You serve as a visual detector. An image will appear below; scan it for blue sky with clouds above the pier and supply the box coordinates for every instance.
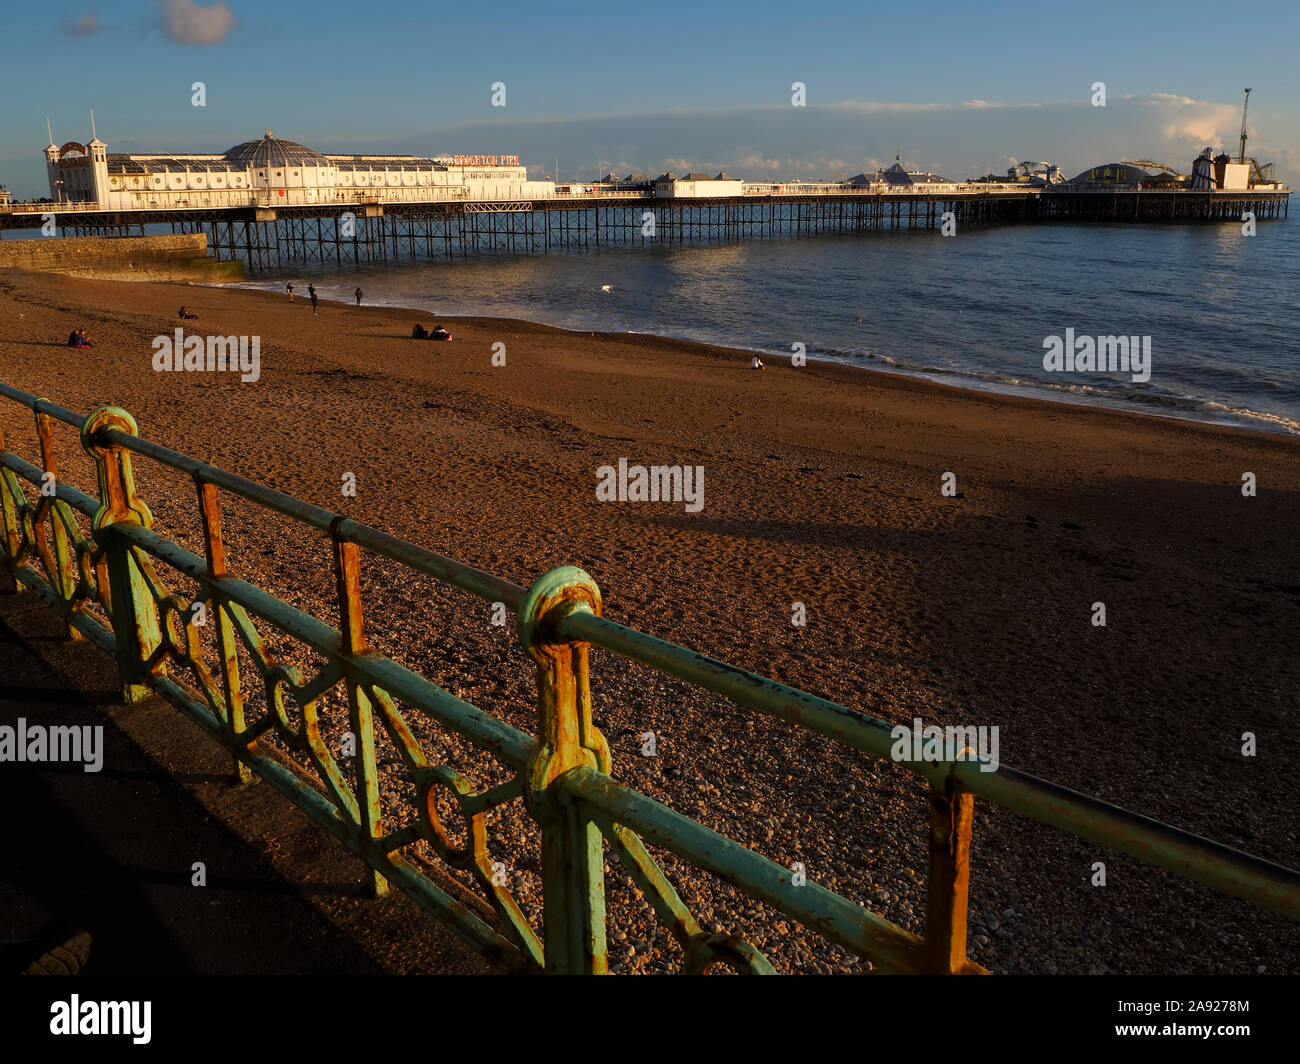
[0,0,1300,199]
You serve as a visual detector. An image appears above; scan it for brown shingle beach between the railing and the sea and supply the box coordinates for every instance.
[0,273,1300,973]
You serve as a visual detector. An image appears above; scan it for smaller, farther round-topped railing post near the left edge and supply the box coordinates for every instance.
[81,406,164,702]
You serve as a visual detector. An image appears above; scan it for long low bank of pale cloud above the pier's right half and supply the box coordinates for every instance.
[408,92,1300,181]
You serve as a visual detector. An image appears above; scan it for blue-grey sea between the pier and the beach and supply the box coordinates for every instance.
[226,221,1300,434]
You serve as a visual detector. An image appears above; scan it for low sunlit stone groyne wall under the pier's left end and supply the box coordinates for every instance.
[0,233,244,282]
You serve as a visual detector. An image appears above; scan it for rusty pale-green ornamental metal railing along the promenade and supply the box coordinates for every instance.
[0,384,1300,973]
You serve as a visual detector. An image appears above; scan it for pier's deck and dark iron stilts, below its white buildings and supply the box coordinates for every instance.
[0,185,1291,272]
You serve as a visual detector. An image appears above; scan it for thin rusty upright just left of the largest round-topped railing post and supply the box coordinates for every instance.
[333,522,389,898]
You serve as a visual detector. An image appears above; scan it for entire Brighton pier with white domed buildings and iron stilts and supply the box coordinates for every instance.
[0,129,1290,271]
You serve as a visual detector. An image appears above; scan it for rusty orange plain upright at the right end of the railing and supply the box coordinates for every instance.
[926,777,975,976]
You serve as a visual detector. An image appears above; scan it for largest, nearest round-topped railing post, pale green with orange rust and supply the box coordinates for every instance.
[519,566,610,974]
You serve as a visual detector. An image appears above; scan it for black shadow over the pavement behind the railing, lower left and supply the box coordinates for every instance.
[0,580,381,976]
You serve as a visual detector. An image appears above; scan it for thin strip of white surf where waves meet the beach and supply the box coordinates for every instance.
[218,274,1300,438]
